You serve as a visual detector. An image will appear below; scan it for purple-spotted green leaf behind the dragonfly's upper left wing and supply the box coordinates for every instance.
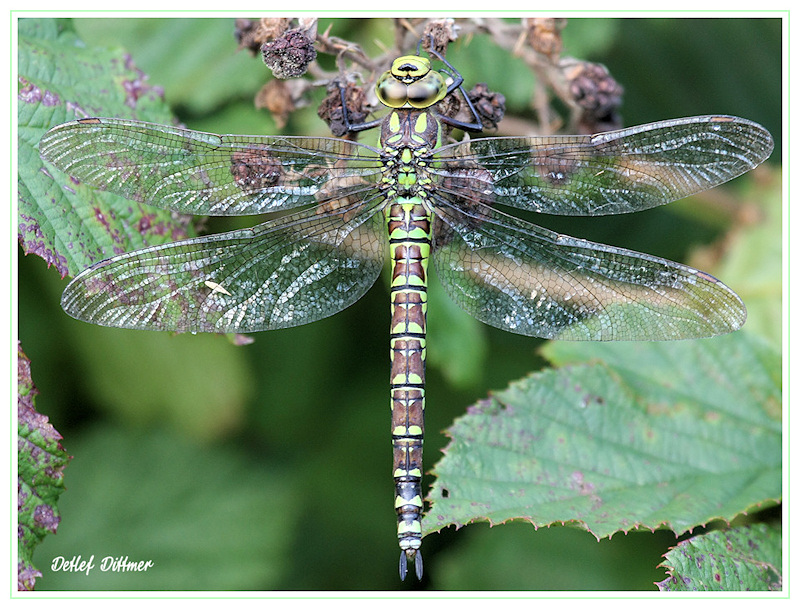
[17,19,190,277]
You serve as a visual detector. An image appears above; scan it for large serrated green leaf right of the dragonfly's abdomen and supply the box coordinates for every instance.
[425,332,781,538]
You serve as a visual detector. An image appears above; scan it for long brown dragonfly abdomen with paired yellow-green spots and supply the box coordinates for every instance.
[386,197,431,577]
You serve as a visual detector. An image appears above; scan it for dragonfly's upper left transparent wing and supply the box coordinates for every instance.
[39,118,380,216]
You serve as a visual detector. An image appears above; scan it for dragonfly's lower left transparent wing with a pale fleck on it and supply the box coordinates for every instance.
[61,198,387,332]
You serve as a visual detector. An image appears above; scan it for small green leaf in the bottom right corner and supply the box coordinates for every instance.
[658,523,783,592]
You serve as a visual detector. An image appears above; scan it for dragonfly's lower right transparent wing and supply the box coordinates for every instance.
[433,200,746,340]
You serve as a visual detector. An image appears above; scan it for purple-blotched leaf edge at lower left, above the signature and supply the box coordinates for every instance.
[17,343,71,590]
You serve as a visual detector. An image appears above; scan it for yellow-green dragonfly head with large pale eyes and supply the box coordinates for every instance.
[375,55,447,109]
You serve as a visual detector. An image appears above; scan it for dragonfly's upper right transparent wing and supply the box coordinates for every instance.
[429,116,773,216]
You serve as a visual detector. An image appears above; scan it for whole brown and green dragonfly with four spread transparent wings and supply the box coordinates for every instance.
[39,48,773,579]
